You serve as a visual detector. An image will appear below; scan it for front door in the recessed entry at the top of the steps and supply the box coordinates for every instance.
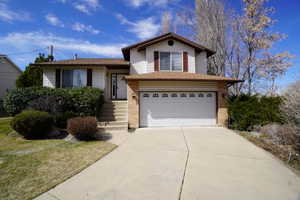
[111,73,127,99]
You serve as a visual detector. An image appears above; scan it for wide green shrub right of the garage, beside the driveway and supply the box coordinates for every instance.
[228,95,283,131]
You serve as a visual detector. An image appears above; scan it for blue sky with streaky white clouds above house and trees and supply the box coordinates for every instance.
[0,0,300,85]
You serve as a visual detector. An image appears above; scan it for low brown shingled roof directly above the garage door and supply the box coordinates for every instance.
[125,72,242,83]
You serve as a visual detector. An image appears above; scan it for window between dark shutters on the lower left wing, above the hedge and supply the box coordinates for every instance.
[62,69,87,88]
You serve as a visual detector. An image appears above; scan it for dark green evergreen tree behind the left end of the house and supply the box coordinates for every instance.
[16,53,54,88]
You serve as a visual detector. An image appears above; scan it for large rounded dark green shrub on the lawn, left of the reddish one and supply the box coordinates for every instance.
[11,110,53,139]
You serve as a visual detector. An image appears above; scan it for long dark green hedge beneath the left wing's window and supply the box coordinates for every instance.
[4,87,103,116]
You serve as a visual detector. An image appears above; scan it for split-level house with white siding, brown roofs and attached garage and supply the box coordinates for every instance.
[39,33,239,128]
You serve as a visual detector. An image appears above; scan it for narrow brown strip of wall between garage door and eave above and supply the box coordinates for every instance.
[140,81,217,91]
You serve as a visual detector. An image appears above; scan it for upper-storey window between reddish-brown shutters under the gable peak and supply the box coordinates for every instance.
[159,52,182,72]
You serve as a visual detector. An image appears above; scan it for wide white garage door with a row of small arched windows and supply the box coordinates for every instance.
[140,92,216,127]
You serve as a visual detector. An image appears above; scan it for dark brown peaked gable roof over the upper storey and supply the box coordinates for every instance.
[122,32,216,60]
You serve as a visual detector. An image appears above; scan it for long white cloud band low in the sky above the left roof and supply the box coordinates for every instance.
[0,32,127,57]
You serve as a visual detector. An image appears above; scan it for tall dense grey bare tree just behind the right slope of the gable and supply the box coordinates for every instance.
[194,0,227,75]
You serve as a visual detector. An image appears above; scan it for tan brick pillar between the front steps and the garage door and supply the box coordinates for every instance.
[127,81,140,128]
